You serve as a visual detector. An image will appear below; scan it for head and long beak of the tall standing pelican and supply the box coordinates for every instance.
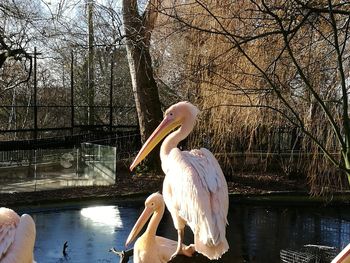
[130,101,199,171]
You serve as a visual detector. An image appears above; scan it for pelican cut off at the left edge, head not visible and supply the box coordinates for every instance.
[0,207,36,263]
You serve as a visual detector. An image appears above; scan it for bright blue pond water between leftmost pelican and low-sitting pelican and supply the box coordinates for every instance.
[32,205,140,263]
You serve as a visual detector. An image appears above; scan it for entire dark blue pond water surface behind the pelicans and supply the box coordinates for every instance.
[21,200,350,263]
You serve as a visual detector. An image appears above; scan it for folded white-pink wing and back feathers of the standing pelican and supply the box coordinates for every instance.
[163,148,229,250]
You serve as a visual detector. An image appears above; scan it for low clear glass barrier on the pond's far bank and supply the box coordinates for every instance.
[0,143,116,193]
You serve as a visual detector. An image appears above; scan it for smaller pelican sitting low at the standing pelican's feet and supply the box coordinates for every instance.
[125,193,194,263]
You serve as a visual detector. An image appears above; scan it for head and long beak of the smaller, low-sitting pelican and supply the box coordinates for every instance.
[125,193,165,249]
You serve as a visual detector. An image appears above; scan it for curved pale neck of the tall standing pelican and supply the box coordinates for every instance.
[160,118,196,159]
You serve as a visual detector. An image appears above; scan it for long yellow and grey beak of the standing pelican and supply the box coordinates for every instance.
[130,116,181,171]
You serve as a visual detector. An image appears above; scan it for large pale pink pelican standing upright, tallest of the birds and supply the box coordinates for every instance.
[130,102,229,259]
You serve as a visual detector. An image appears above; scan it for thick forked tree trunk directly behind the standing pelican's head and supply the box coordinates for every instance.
[123,0,162,168]
